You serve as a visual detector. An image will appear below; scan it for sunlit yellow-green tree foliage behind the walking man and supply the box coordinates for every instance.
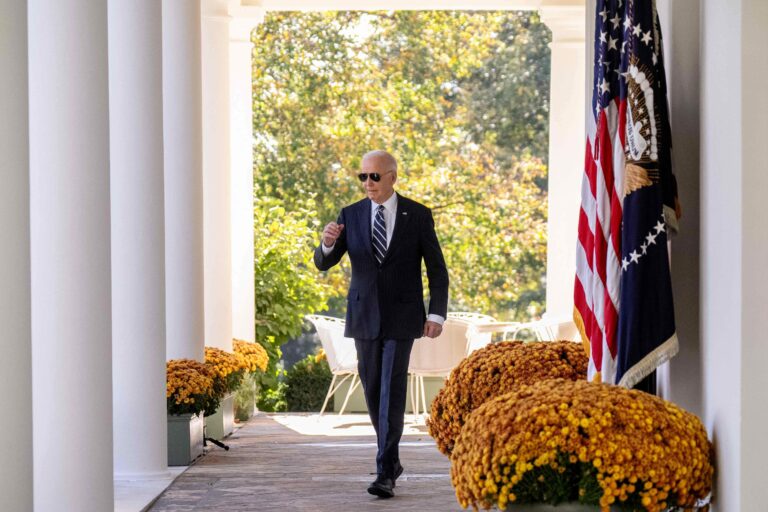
[253,11,549,320]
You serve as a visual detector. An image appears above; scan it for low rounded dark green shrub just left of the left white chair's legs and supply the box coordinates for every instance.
[285,355,332,412]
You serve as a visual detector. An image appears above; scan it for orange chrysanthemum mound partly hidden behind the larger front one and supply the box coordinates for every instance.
[427,341,588,455]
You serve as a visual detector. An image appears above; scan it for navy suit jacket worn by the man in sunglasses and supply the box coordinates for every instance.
[315,194,448,339]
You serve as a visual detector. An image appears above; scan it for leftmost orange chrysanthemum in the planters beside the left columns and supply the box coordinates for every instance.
[165,359,218,415]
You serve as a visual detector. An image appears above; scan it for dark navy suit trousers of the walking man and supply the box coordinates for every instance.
[355,338,413,478]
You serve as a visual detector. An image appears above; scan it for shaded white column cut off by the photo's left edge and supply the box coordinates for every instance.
[0,0,32,510]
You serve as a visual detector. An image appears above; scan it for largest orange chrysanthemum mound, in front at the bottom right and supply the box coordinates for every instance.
[451,379,713,512]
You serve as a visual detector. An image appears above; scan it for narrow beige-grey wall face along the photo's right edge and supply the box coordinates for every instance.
[736,0,768,506]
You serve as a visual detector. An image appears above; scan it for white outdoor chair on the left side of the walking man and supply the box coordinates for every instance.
[305,315,360,415]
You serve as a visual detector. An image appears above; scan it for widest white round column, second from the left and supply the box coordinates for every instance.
[29,0,114,512]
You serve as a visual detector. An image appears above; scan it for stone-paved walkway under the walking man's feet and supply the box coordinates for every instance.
[149,414,463,512]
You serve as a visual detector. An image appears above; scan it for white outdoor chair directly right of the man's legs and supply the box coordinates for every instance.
[408,313,474,416]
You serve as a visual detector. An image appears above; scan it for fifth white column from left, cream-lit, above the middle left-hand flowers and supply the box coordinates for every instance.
[202,0,232,350]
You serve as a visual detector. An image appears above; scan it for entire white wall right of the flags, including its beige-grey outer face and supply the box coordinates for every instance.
[700,0,768,512]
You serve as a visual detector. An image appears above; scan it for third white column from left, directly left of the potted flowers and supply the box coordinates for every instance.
[109,0,168,479]
